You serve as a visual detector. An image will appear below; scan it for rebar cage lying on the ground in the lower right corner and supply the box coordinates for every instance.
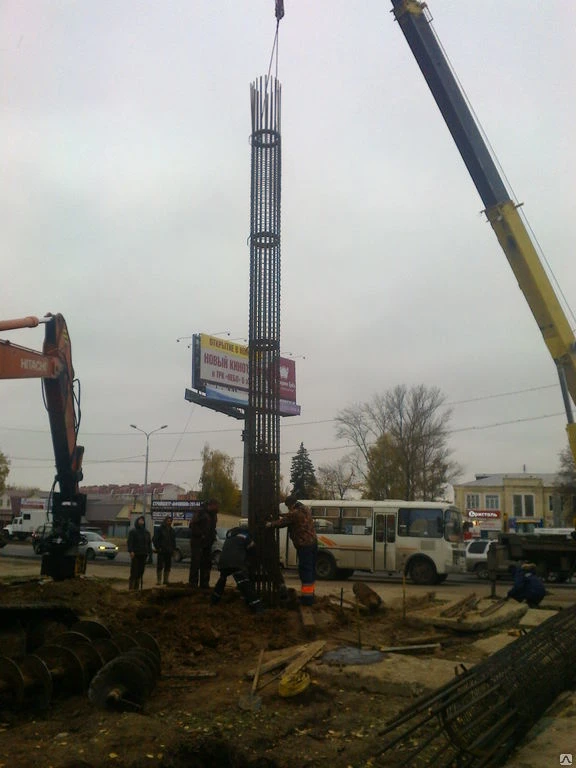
[378,605,576,768]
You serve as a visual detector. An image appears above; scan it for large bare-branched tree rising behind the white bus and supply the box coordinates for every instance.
[336,384,460,500]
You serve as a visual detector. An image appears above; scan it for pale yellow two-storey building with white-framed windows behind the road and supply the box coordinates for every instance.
[454,473,574,538]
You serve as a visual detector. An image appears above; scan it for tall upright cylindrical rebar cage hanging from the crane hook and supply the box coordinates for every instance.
[245,77,282,603]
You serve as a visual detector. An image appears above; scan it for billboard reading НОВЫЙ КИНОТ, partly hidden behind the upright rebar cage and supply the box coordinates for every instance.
[192,333,300,416]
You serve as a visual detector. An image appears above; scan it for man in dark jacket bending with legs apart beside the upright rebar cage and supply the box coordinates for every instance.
[210,527,264,613]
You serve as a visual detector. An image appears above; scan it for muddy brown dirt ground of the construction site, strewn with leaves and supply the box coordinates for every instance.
[0,558,576,768]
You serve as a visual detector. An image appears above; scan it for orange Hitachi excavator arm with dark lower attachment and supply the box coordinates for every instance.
[0,314,86,580]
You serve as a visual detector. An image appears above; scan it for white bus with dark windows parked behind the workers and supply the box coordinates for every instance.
[280,499,466,584]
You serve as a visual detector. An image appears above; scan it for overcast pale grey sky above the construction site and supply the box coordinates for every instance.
[0,0,576,496]
